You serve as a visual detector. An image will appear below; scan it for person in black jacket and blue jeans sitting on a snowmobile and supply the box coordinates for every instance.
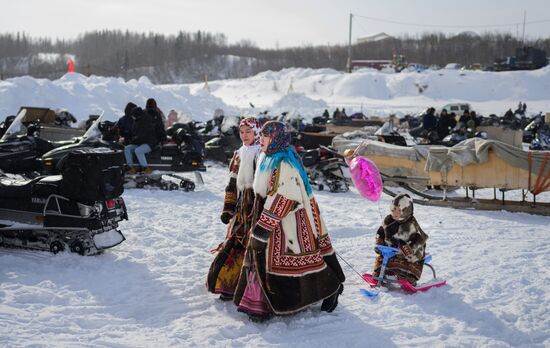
[124,107,157,174]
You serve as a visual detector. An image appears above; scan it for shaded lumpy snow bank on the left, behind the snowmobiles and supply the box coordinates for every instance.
[0,73,238,121]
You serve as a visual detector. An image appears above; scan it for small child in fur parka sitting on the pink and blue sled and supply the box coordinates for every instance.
[373,193,428,285]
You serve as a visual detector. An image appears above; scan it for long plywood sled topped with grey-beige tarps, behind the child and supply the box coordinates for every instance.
[340,138,550,216]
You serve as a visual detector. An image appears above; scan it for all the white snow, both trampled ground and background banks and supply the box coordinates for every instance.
[0,68,550,347]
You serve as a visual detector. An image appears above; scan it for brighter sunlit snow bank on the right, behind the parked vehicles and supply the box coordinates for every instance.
[195,67,550,115]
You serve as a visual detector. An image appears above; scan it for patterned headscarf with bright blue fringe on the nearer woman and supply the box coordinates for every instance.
[260,121,312,195]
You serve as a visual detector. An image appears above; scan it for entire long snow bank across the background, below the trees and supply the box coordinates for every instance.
[0,66,550,121]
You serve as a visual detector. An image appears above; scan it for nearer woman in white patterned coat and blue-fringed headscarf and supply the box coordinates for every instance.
[234,121,345,320]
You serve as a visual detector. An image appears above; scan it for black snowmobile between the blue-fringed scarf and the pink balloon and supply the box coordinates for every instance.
[300,145,349,192]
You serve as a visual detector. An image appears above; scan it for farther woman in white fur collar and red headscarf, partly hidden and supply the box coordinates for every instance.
[206,118,260,300]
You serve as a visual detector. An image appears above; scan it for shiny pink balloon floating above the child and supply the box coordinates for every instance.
[347,156,384,202]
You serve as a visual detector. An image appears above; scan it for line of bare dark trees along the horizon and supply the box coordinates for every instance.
[0,30,550,83]
